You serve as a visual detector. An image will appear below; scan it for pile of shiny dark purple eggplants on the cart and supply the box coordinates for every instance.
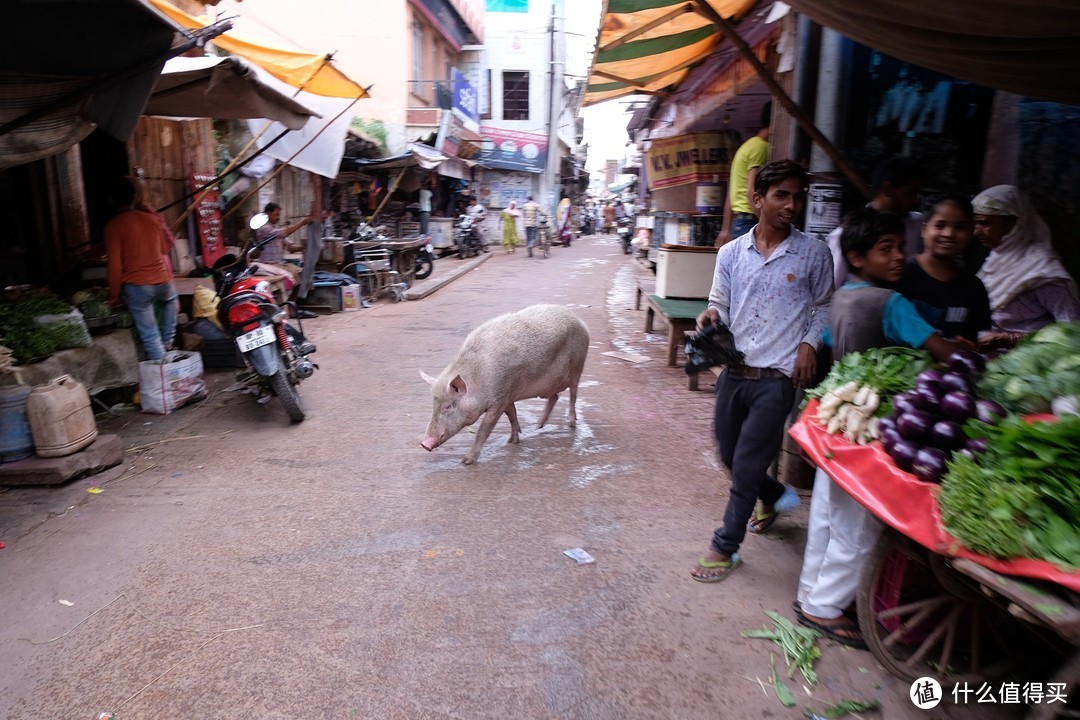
[878,350,1005,483]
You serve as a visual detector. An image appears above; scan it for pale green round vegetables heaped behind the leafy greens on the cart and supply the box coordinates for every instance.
[978,323,1080,413]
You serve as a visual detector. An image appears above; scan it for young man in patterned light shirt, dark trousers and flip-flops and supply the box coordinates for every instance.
[690,160,833,583]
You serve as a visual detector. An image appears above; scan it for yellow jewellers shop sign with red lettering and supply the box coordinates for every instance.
[646,133,739,190]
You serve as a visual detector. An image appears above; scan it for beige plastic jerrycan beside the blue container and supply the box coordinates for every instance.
[26,375,97,458]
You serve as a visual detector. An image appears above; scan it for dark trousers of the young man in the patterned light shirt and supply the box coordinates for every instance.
[713,371,795,557]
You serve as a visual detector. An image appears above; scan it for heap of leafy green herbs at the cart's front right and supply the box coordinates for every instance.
[939,416,1080,568]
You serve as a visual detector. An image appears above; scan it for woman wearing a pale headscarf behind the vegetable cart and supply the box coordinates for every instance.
[972,185,1080,334]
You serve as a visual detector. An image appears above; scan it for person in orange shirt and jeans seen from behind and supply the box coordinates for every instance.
[105,177,178,361]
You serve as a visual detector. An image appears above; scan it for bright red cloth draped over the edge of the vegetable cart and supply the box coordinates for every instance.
[788,400,1080,593]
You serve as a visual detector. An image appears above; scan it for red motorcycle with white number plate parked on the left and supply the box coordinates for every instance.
[214,213,319,422]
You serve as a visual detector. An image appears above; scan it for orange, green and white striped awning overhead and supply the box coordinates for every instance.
[583,0,757,105]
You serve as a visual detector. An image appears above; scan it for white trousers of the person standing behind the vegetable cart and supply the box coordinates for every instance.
[798,468,882,619]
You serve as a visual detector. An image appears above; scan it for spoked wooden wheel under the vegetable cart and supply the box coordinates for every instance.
[855,529,1031,683]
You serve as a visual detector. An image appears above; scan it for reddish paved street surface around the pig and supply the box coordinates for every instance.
[0,236,1021,720]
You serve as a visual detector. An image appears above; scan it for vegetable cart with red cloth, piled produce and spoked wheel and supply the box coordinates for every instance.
[789,326,1080,703]
